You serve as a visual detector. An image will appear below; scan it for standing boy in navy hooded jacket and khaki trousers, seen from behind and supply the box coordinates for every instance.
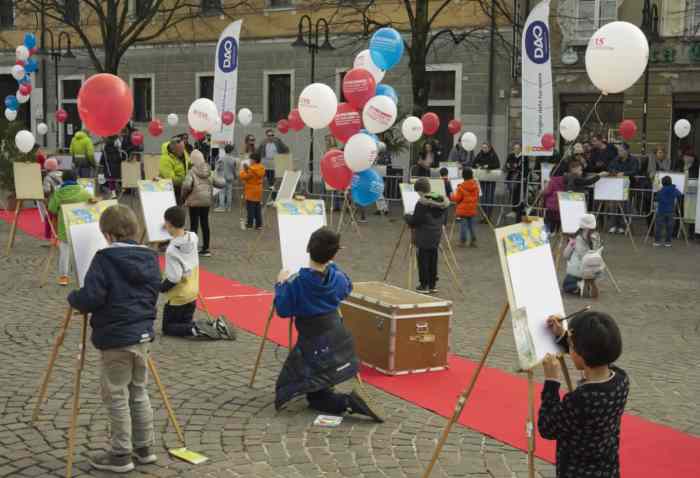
[68,205,160,473]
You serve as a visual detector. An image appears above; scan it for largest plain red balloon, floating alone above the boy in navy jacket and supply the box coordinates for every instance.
[78,73,134,136]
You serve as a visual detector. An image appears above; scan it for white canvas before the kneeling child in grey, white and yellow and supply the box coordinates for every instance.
[138,179,177,242]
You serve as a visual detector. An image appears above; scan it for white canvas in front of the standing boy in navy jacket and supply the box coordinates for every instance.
[61,199,117,287]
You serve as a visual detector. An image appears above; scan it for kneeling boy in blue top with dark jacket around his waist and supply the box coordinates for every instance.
[275,227,384,422]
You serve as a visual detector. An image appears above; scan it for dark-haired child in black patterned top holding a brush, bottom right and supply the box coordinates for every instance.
[538,311,630,478]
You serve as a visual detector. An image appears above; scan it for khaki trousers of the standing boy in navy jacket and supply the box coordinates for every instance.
[100,344,153,455]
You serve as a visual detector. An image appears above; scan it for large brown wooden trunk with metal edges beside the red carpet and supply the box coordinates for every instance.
[340,282,452,375]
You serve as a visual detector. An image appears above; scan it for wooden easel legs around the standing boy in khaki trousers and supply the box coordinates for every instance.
[32,307,185,478]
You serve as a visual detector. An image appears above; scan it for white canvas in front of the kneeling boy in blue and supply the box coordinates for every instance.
[277,200,326,274]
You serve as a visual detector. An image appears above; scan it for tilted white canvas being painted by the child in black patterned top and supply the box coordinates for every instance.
[495,221,565,370]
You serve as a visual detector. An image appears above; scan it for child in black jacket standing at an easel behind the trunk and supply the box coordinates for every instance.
[405,178,450,294]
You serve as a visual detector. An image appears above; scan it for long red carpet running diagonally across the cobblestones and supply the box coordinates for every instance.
[5,213,700,478]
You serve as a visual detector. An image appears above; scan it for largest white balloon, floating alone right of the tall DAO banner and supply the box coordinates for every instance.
[586,22,649,93]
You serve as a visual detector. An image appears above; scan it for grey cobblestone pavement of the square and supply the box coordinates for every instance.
[0,196,700,478]
